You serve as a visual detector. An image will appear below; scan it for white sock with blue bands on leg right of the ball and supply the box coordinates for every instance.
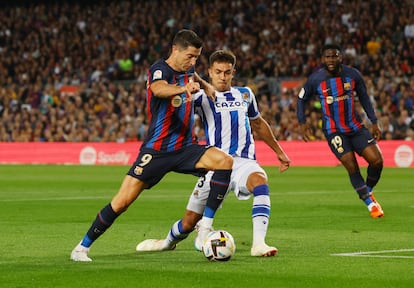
[252,184,270,246]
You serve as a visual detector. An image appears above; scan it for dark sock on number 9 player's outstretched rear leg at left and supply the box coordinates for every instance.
[81,203,119,247]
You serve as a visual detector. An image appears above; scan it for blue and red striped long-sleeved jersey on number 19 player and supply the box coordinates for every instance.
[296,65,377,135]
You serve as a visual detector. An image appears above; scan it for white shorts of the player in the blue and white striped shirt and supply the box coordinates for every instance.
[187,157,267,214]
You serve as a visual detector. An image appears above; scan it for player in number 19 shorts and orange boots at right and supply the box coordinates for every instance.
[297,44,384,218]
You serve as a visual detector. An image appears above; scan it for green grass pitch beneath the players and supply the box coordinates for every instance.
[0,165,414,288]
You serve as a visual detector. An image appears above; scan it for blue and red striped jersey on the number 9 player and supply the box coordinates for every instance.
[143,60,195,152]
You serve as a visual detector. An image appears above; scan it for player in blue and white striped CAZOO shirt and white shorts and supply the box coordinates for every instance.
[137,50,290,256]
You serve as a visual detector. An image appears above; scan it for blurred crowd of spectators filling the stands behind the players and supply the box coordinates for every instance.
[0,0,414,142]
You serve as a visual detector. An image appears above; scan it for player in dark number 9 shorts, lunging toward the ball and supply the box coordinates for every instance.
[70,29,233,261]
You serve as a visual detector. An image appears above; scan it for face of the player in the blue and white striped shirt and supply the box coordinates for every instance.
[208,62,234,92]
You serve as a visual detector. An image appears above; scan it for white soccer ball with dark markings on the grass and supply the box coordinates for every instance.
[203,230,236,261]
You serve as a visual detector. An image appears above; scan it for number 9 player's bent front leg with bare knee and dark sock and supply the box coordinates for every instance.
[196,147,233,231]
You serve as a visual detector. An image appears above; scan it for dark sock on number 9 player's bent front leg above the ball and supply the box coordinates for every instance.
[203,169,232,220]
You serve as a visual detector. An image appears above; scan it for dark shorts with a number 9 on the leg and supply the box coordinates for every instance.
[127,144,212,189]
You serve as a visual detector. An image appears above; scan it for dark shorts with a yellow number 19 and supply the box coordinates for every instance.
[326,127,377,159]
